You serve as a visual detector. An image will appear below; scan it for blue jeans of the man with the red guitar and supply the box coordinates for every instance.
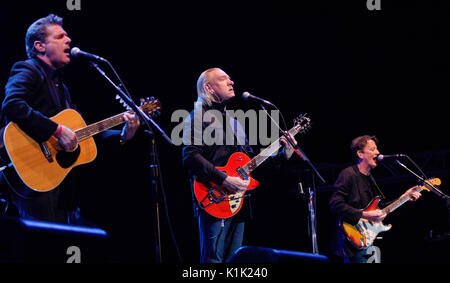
[198,212,245,263]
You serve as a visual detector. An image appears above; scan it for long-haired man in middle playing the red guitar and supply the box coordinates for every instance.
[183,68,294,263]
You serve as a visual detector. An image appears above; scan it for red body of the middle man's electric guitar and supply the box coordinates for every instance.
[194,152,259,219]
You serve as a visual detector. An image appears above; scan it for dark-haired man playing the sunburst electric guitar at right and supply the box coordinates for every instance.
[330,135,421,263]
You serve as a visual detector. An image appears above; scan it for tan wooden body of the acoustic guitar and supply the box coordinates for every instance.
[3,109,97,197]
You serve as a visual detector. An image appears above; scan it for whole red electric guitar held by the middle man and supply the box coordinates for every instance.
[194,114,311,219]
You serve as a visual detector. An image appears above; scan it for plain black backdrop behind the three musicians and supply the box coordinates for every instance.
[0,0,450,263]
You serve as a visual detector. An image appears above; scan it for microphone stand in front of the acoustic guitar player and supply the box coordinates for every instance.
[90,61,174,263]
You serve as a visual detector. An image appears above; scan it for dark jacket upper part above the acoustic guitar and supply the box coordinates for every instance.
[1,58,75,142]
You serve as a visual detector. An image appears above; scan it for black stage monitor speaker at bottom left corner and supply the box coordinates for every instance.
[0,217,110,263]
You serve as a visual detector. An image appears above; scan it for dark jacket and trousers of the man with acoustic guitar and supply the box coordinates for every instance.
[0,58,120,223]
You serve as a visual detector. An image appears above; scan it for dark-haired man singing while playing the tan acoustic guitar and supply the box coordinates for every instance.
[1,14,139,225]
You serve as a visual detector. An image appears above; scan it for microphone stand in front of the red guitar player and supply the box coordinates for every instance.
[260,103,325,254]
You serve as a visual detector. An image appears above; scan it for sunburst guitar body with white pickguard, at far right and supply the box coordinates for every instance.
[341,197,392,249]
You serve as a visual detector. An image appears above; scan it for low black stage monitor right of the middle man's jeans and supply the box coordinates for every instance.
[228,246,329,263]
